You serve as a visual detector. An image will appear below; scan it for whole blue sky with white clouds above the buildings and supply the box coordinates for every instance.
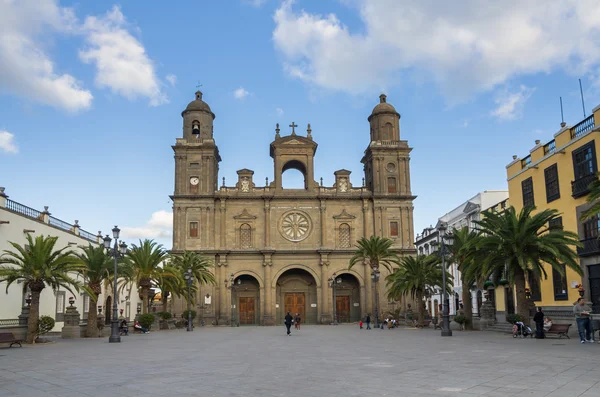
[0,0,600,248]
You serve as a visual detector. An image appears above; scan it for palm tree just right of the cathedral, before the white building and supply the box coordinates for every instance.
[386,254,452,325]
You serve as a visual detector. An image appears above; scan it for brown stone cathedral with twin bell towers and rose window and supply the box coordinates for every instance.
[171,91,416,325]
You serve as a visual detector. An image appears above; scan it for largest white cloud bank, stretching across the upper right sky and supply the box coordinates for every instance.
[273,0,600,100]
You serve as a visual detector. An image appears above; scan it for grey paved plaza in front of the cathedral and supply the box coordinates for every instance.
[0,325,600,397]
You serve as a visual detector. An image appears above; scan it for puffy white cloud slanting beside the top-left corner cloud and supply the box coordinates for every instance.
[79,6,168,106]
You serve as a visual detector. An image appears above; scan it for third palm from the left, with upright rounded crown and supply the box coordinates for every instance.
[124,239,168,314]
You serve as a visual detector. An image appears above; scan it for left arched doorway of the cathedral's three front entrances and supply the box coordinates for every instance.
[233,274,260,325]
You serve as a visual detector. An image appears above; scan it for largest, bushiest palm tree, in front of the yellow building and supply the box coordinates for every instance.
[476,206,583,320]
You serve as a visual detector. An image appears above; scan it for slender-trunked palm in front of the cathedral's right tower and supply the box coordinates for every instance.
[346,236,398,326]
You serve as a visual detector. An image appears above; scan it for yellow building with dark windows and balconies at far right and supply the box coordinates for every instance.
[506,106,600,313]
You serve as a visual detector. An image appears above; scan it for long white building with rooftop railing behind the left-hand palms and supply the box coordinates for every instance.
[0,187,139,332]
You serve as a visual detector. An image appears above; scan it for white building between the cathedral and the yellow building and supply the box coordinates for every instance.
[415,190,508,316]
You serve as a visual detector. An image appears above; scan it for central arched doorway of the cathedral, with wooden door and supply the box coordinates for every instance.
[275,269,317,324]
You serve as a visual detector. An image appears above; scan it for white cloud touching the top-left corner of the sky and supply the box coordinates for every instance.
[0,0,93,112]
